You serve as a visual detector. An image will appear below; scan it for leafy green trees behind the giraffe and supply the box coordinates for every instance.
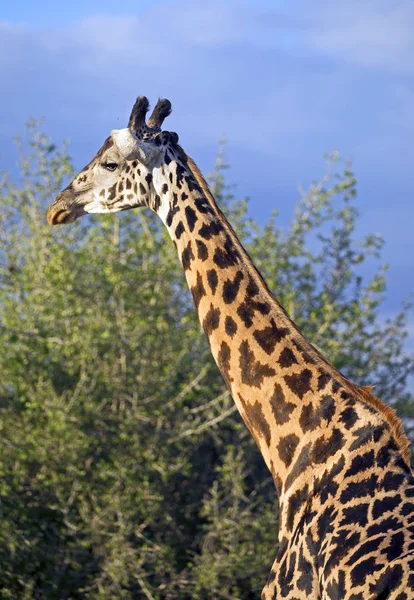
[0,123,413,600]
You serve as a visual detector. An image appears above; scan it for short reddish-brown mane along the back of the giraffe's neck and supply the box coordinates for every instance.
[183,151,411,468]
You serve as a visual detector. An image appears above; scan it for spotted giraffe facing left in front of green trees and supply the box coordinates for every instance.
[47,96,414,600]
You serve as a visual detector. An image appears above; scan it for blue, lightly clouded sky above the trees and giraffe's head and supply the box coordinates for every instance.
[0,0,414,356]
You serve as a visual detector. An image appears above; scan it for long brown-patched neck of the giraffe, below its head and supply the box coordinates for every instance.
[147,153,410,536]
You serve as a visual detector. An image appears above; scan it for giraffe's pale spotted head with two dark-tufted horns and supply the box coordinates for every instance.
[47,96,178,225]
